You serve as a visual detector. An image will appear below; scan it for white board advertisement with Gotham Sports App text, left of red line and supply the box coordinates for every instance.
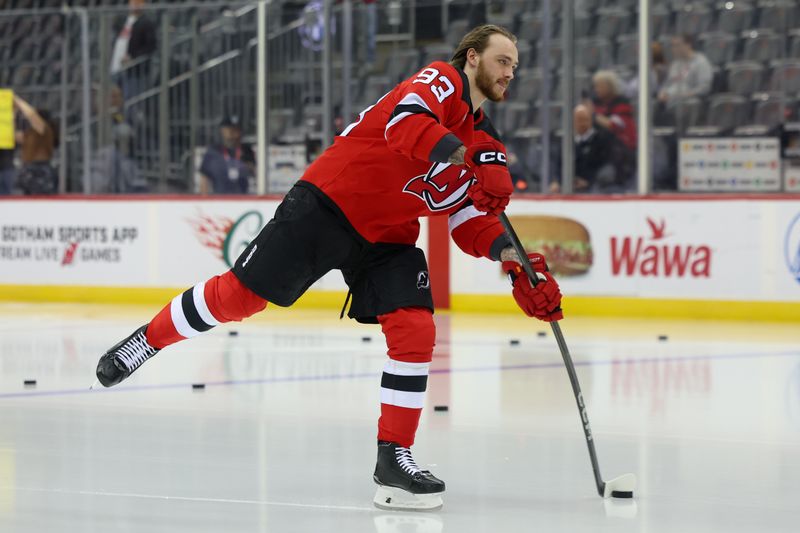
[0,196,428,291]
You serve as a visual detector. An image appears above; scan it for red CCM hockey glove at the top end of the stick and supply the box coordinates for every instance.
[464,141,514,215]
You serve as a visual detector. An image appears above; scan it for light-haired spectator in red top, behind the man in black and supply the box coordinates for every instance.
[589,70,636,152]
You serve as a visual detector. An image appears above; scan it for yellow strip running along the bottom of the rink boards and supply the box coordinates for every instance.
[0,285,800,322]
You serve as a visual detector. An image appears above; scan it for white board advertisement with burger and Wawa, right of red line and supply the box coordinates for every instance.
[451,199,800,301]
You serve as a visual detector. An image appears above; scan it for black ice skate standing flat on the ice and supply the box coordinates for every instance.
[372,441,444,511]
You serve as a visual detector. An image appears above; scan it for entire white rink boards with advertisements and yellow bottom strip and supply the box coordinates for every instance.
[0,195,800,320]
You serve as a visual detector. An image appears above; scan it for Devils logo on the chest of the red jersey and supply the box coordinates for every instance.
[403,163,475,211]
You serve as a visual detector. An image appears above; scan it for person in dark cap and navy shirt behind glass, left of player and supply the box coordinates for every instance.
[200,116,255,194]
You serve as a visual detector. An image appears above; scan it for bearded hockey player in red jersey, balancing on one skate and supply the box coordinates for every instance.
[97,25,562,509]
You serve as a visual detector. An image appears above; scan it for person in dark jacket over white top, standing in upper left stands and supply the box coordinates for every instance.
[111,0,157,98]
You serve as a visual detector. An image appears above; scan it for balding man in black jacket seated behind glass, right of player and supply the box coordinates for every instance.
[550,104,624,193]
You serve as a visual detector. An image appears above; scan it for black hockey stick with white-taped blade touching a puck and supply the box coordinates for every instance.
[499,213,636,498]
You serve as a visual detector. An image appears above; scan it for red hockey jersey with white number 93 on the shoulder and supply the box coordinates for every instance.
[301,61,507,259]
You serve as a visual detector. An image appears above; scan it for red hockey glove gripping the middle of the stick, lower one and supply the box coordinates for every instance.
[503,254,564,322]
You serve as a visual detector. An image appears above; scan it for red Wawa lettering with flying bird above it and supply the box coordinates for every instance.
[611,217,711,278]
